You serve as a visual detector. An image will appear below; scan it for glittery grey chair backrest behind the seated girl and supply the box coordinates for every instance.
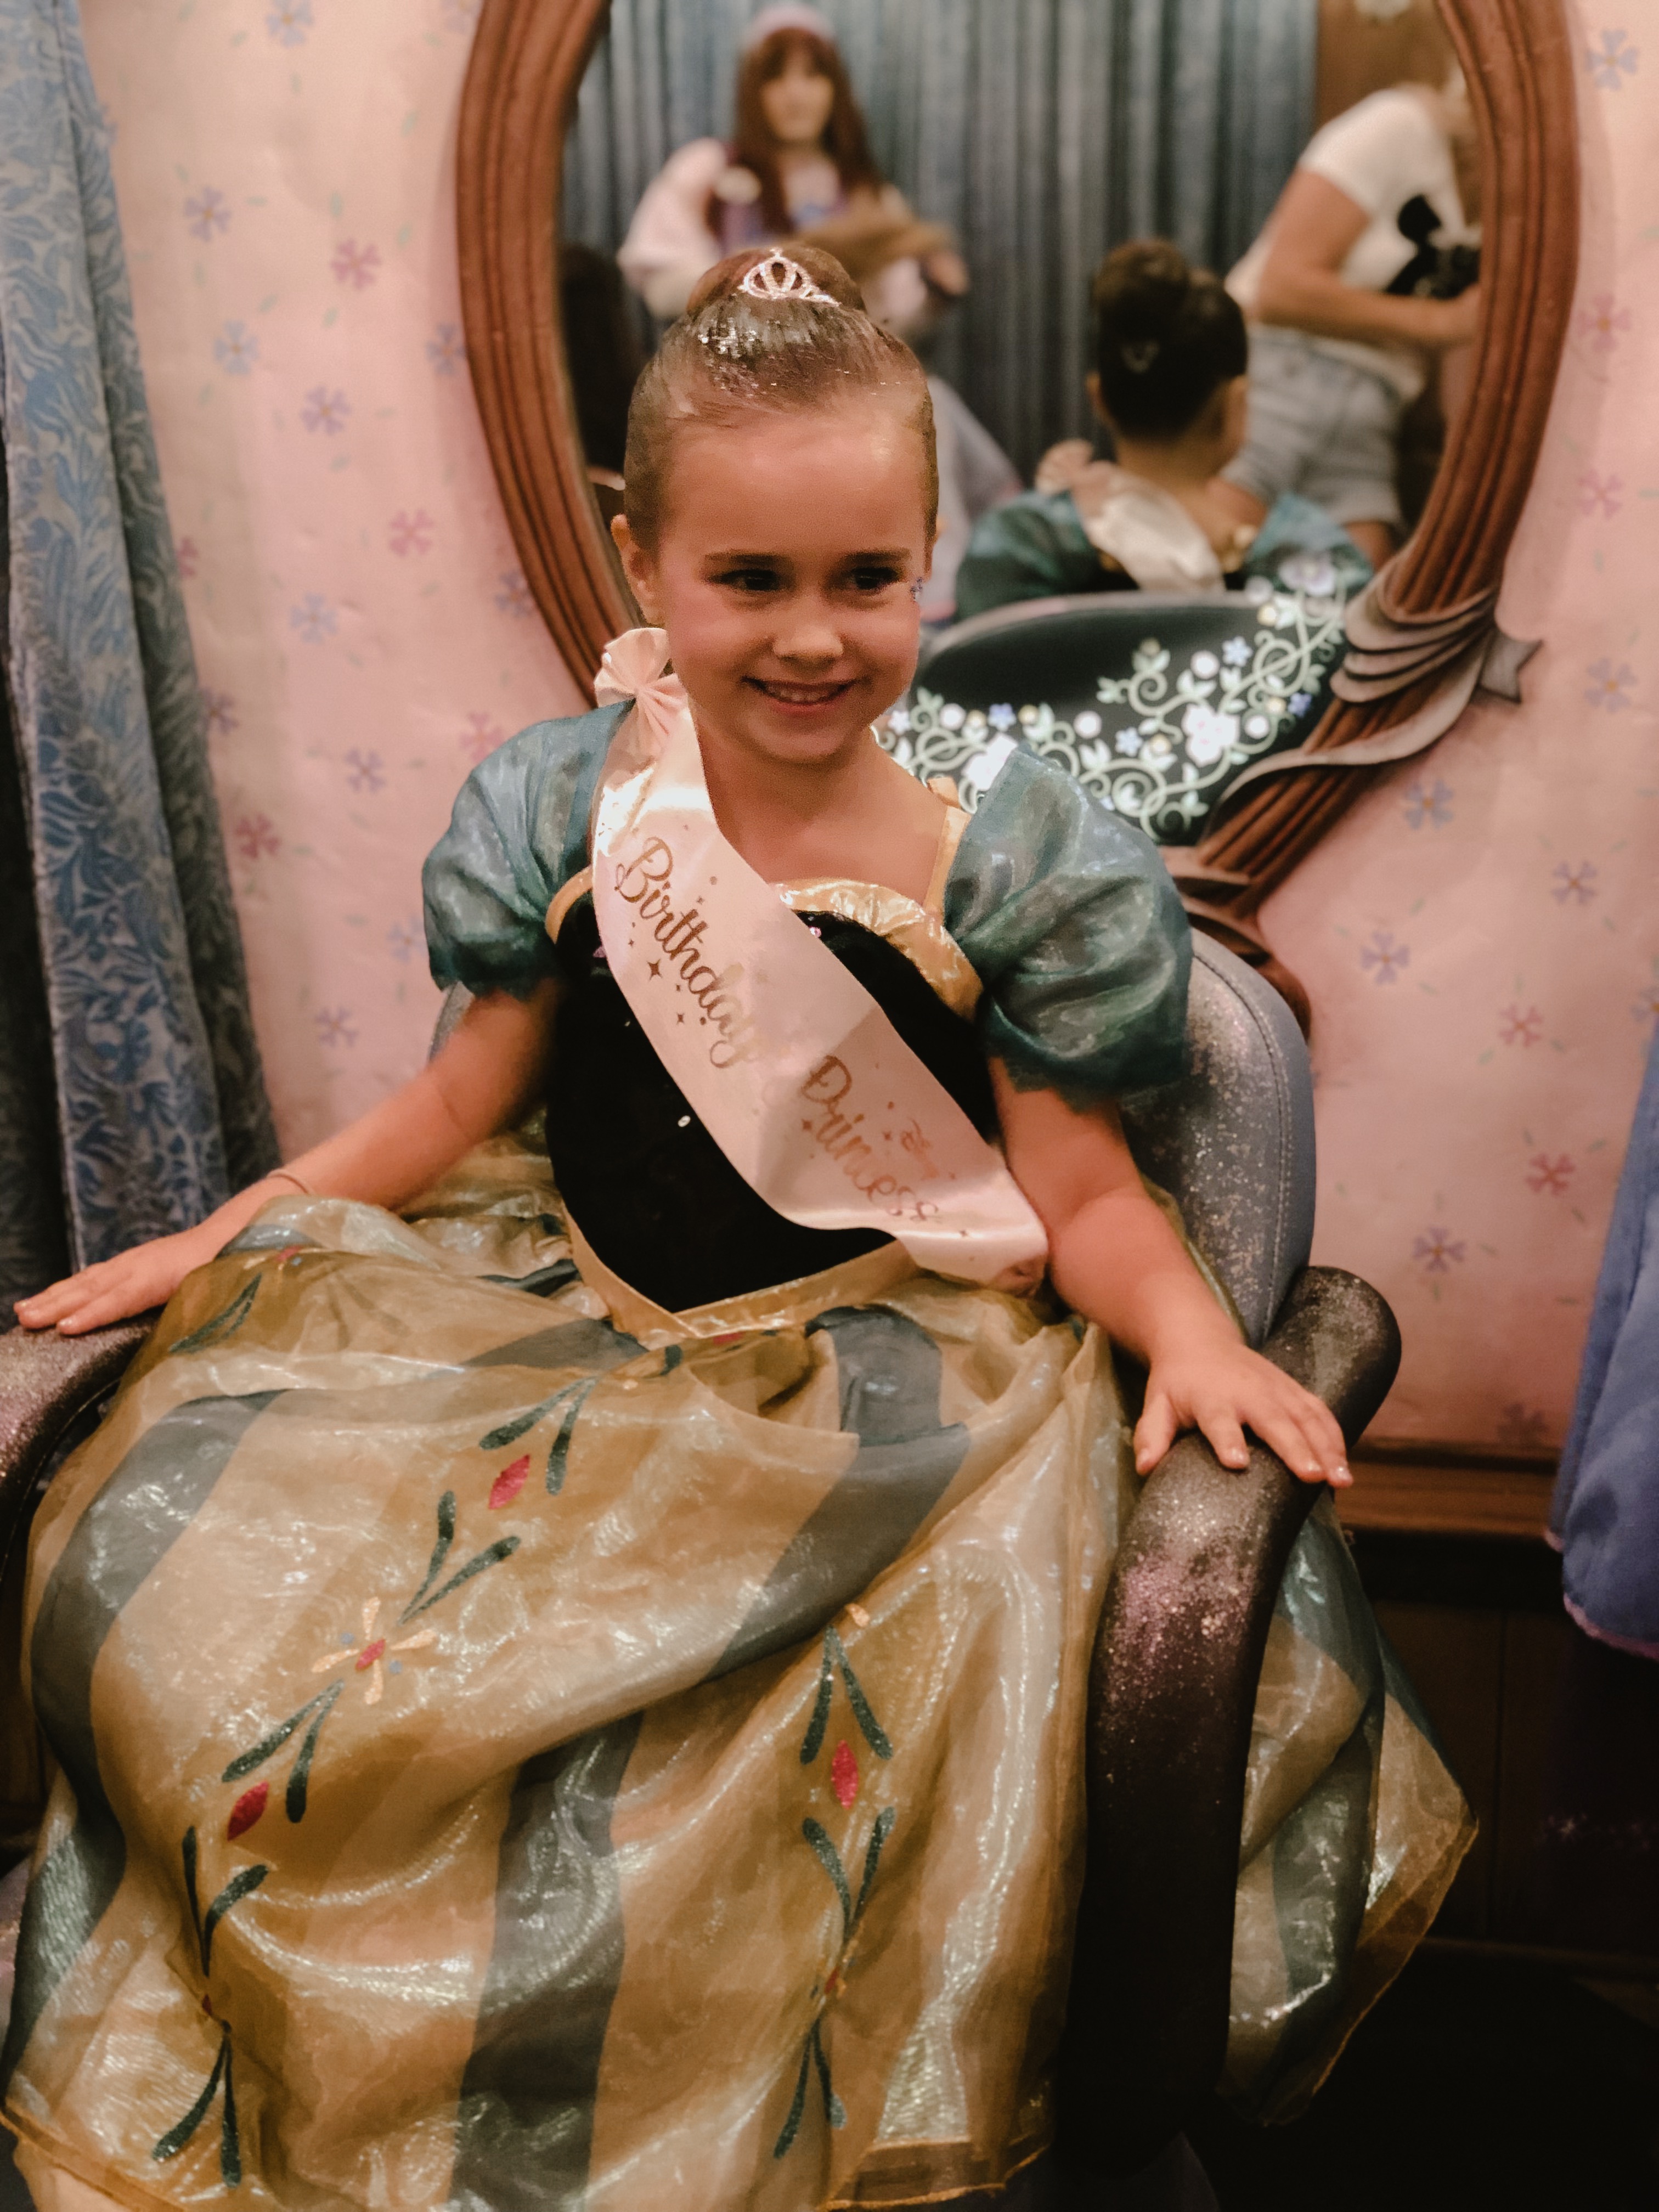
[431,920,1314,1345]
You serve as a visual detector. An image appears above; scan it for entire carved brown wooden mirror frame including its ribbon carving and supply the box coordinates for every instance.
[458,0,1579,958]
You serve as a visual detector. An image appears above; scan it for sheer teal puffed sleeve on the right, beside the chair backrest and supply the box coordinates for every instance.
[945,750,1192,1106]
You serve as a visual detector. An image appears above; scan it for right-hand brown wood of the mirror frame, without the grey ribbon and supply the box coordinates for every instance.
[1194,0,1579,918]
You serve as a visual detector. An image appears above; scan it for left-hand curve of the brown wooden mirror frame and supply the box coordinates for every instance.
[456,0,633,686]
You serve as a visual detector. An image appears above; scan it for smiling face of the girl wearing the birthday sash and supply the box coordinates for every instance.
[613,398,931,768]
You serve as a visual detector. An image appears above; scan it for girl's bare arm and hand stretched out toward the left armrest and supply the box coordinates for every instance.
[18,982,557,1336]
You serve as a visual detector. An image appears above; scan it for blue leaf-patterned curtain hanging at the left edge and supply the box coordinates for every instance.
[0,0,276,1323]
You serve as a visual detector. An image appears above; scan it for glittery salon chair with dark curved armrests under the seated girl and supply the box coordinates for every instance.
[0,938,1400,2176]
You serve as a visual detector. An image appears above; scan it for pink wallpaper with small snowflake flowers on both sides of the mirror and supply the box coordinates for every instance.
[84,0,1659,1442]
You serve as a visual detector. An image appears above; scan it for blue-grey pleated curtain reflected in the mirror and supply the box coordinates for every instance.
[564,0,1318,473]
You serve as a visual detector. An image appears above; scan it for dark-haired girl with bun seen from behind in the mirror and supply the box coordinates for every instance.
[956,239,1372,617]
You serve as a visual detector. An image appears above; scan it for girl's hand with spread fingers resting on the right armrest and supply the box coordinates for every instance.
[1135,1331,1354,1491]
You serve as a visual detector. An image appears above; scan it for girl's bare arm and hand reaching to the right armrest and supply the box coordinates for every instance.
[991,1062,1352,1487]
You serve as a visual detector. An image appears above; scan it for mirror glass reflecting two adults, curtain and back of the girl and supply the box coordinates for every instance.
[560,0,1480,628]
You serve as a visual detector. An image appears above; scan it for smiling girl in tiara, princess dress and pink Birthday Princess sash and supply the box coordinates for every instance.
[7,252,1462,2212]
